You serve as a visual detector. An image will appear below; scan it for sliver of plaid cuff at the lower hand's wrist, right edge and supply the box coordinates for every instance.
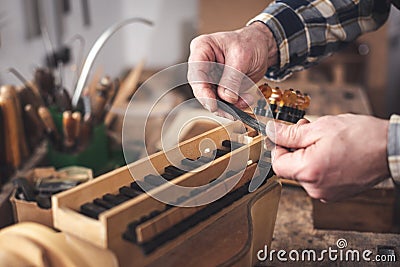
[387,115,400,185]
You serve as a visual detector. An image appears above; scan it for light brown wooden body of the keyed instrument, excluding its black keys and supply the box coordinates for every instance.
[52,122,281,266]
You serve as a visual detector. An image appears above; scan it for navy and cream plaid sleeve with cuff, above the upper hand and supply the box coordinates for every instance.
[248,0,390,80]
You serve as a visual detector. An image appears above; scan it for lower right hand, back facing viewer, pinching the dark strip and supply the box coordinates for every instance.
[267,114,390,201]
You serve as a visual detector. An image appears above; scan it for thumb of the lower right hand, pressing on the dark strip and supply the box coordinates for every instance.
[266,121,315,148]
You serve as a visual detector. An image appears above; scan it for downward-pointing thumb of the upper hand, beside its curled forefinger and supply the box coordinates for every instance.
[217,59,246,104]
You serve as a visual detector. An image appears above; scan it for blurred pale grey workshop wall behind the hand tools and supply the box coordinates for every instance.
[0,0,197,91]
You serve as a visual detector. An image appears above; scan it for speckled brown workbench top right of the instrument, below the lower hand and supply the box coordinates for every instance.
[260,186,400,266]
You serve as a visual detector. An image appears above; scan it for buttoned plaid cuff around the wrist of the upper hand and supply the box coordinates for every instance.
[247,2,309,80]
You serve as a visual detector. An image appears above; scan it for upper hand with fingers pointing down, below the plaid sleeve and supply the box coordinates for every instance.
[188,22,277,115]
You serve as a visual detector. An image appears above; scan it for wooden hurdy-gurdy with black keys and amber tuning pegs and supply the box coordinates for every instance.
[53,84,310,266]
